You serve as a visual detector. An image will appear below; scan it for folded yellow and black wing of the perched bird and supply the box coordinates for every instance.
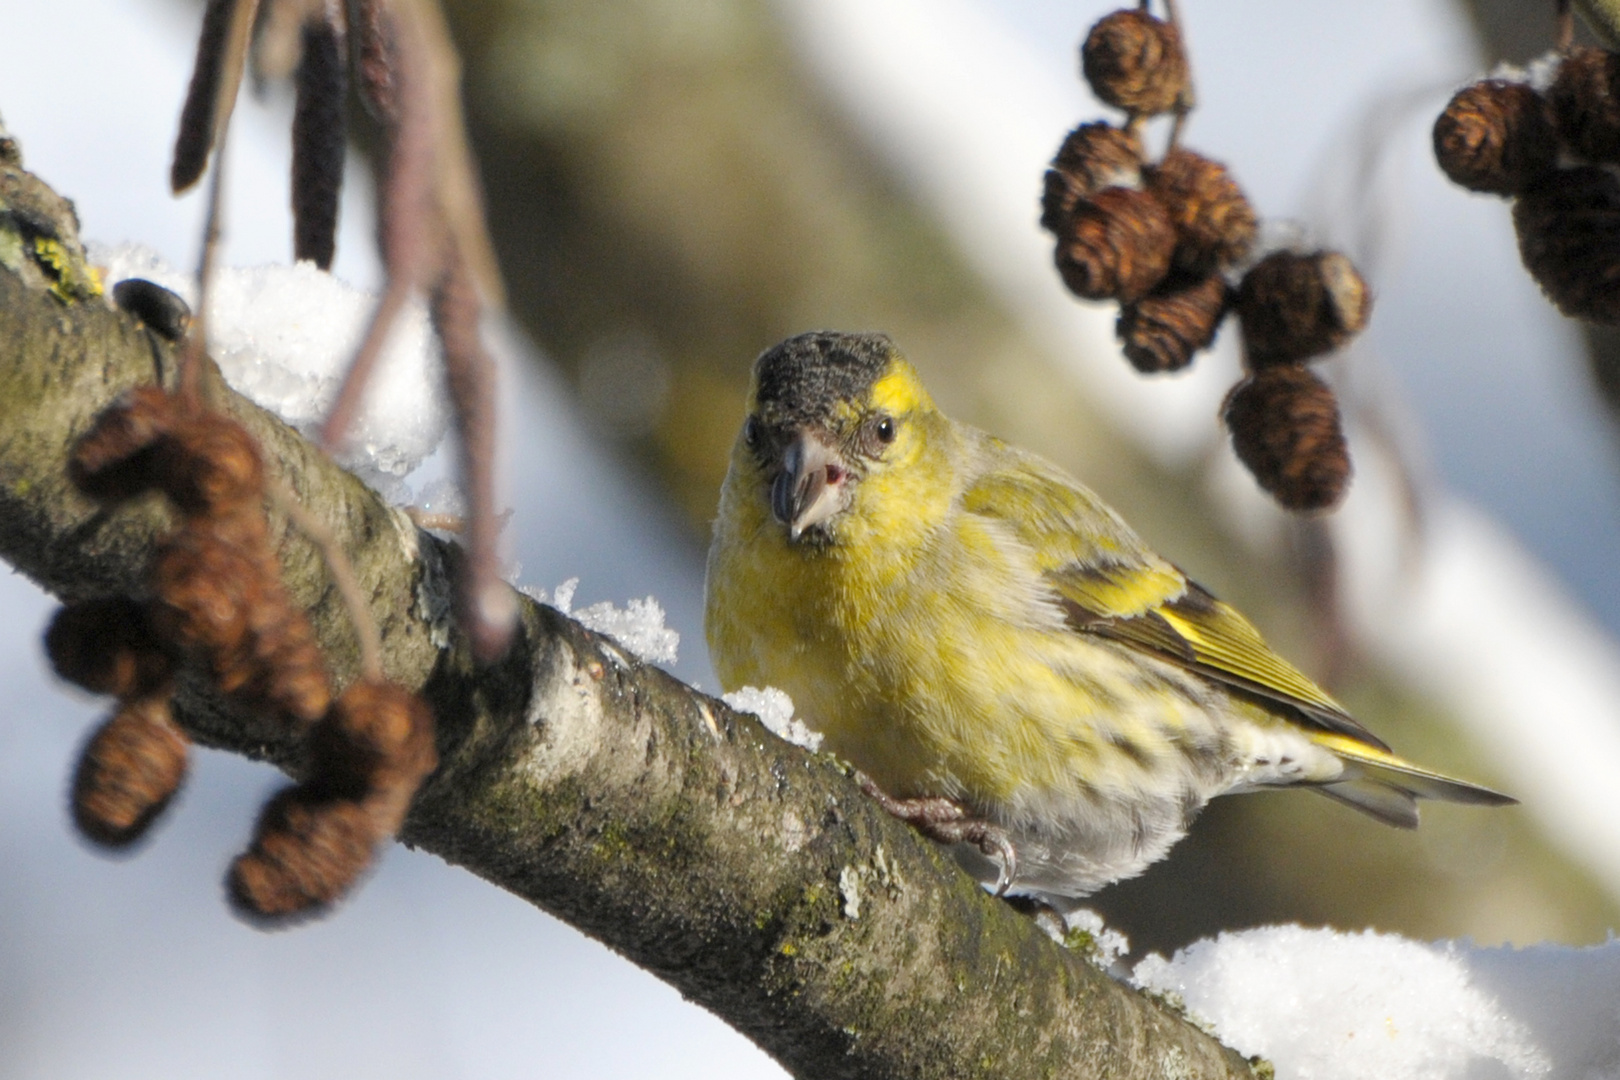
[962,440,1388,750]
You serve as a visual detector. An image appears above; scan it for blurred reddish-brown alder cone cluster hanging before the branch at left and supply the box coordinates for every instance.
[45,375,437,920]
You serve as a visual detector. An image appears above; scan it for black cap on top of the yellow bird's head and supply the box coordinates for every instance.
[753,330,894,427]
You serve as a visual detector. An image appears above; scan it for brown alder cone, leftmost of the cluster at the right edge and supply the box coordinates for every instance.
[1434,79,1558,194]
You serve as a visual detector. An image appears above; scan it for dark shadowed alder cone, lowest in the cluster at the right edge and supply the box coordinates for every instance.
[1513,165,1620,325]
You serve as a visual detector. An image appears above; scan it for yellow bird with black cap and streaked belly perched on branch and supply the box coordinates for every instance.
[705,330,1515,912]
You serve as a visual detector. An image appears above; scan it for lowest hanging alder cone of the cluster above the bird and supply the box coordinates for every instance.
[1221,366,1349,510]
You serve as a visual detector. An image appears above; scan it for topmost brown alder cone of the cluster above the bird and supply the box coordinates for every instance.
[1081,10,1187,117]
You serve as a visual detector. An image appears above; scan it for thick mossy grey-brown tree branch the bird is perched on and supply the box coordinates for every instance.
[0,148,1251,1078]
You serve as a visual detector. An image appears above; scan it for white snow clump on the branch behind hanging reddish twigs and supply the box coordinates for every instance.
[89,243,449,486]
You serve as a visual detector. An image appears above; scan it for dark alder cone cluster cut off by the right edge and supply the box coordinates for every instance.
[1434,45,1620,325]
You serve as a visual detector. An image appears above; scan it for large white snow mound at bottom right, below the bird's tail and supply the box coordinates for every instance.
[1134,926,1620,1080]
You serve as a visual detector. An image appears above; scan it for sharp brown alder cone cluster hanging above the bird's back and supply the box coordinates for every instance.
[1040,8,1372,510]
